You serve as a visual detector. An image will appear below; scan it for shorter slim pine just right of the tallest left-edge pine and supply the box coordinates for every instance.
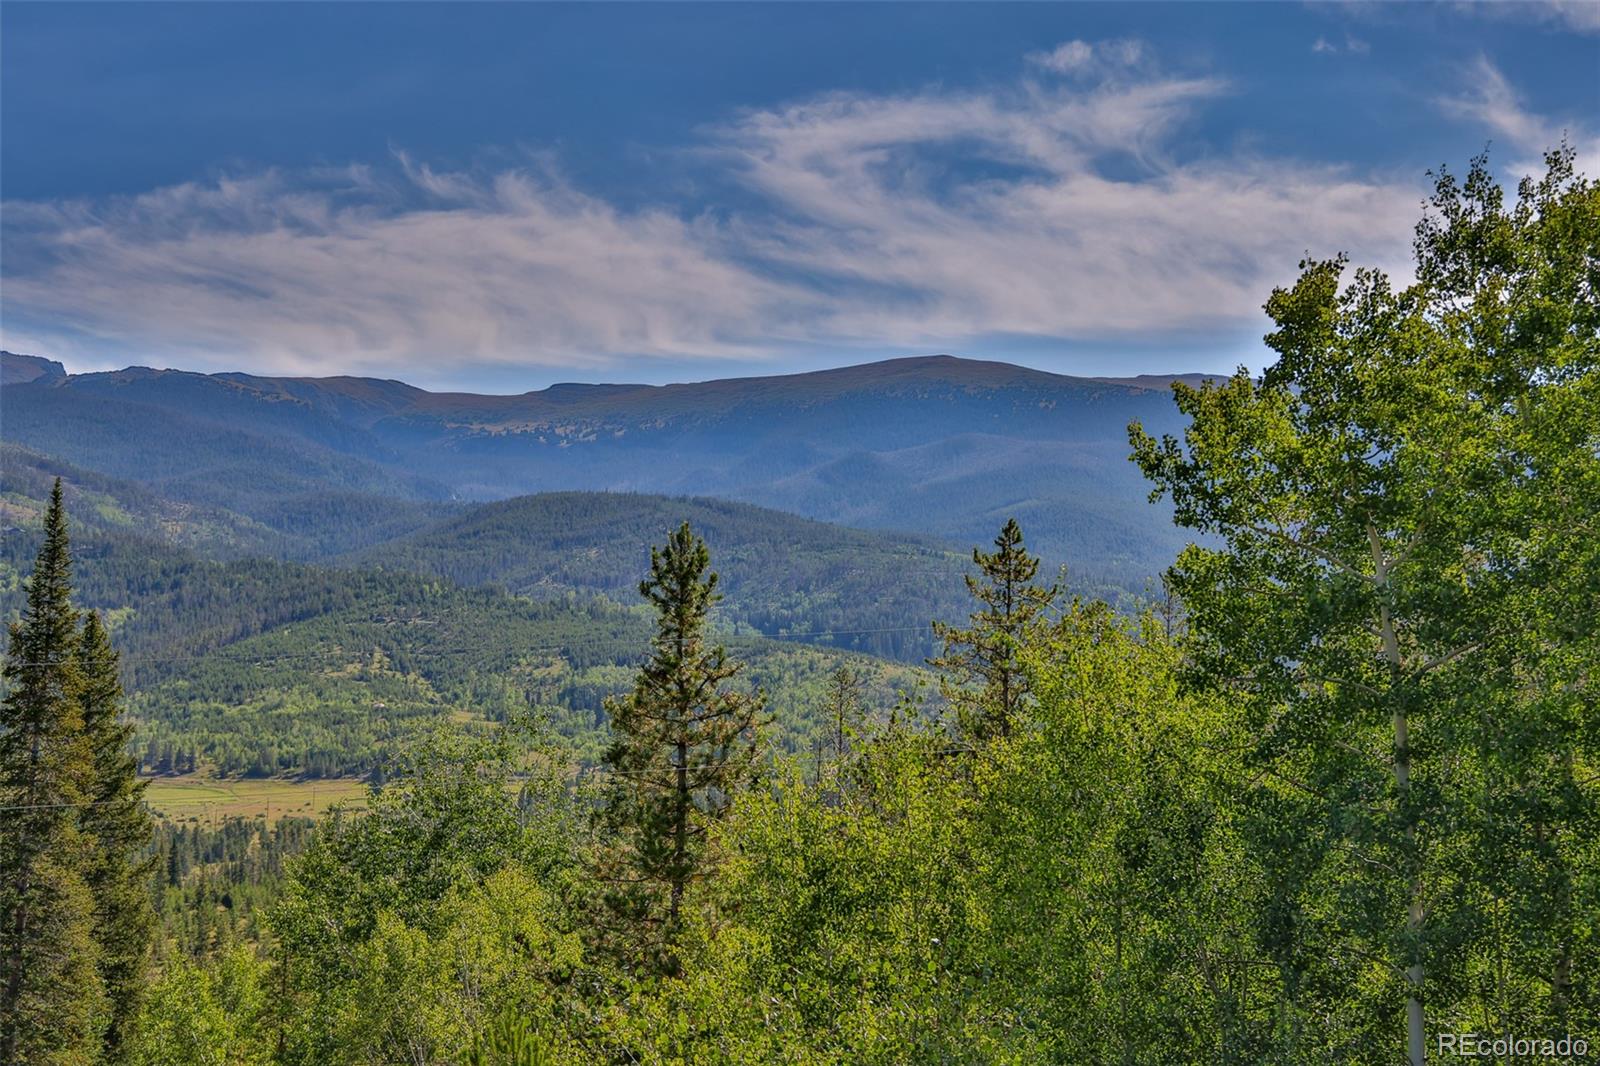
[78,611,155,1061]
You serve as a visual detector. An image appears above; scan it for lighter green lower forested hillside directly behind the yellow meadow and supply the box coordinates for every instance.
[0,502,934,776]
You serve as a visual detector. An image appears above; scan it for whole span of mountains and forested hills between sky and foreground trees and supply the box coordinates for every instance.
[0,354,1196,781]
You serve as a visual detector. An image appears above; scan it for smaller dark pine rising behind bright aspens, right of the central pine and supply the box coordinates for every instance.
[928,519,1059,743]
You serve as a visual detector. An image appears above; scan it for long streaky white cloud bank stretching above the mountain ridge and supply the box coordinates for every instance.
[0,40,1558,379]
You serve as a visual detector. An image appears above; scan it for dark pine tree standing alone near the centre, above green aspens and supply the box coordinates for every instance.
[603,522,763,975]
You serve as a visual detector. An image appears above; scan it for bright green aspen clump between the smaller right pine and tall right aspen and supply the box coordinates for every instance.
[976,603,1277,1063]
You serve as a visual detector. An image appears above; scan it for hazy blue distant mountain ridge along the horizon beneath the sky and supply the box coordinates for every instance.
[0,348,1203,587]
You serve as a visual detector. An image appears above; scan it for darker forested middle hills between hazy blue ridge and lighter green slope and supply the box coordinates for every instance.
[0,460,998,663]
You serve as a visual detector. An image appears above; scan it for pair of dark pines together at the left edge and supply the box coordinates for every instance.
[0,480,154,1066]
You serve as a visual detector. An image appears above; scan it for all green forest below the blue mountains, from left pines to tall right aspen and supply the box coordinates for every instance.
[0,149,1600,1066]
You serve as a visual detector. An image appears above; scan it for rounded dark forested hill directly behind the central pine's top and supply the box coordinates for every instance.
[338,493,970,661]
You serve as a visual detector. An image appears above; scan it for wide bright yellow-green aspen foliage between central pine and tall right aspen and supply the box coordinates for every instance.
[608,605,1248,1064]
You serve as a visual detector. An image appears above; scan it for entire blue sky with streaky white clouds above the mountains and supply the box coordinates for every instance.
[0,0,1600,392]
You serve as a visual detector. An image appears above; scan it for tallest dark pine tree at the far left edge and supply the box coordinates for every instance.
[0,479,102,1066]
